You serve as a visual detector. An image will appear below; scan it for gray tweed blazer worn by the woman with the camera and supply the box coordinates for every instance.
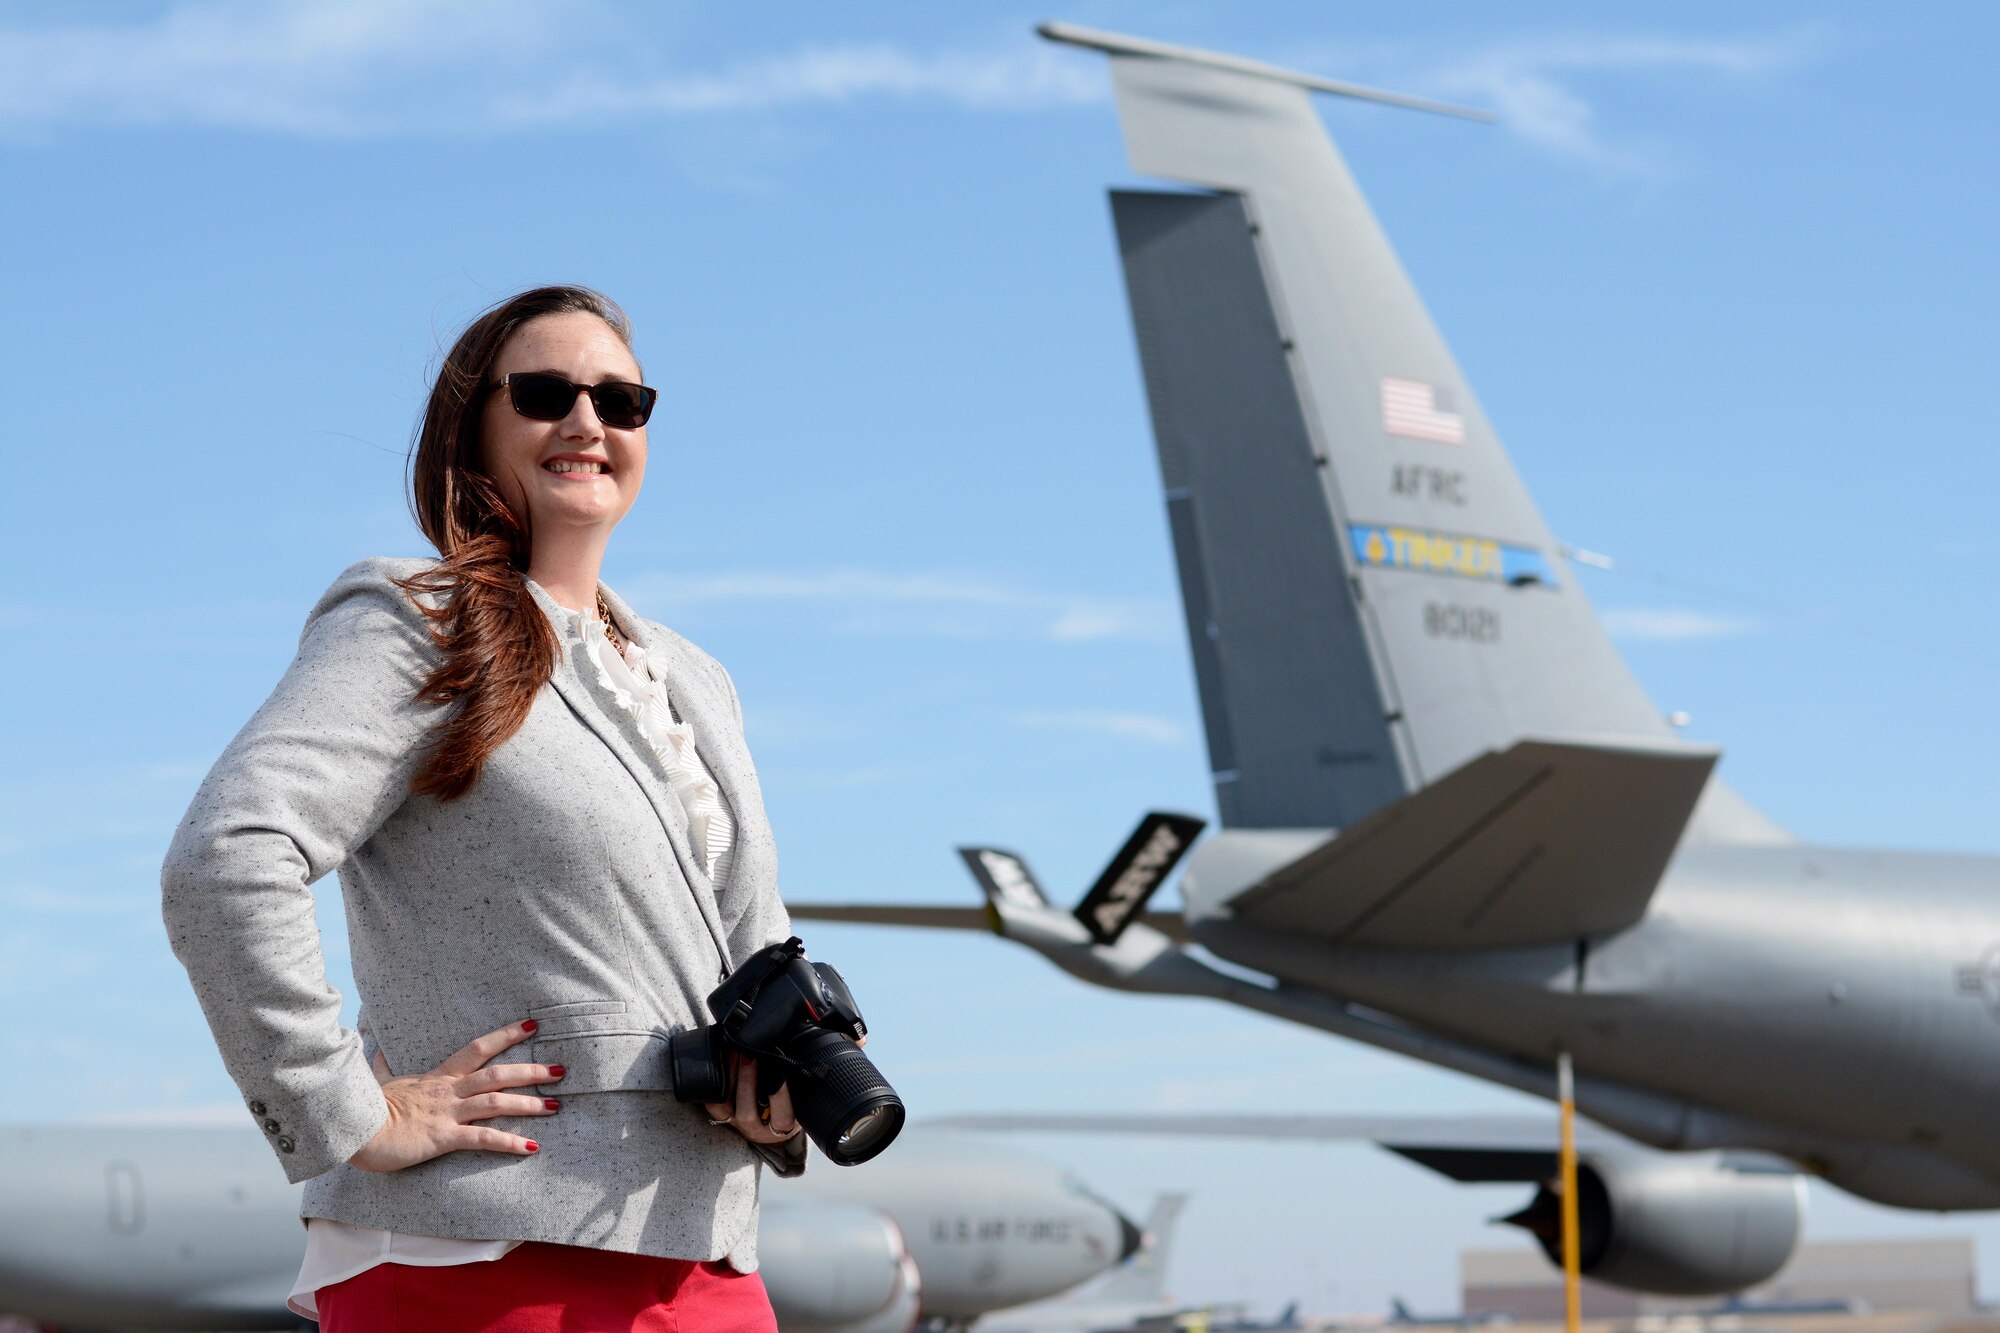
[162,558,790,1271]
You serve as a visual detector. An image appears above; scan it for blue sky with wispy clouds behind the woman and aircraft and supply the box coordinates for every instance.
[0,0,2000,1309]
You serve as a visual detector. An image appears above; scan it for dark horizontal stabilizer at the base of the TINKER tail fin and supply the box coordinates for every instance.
[1228,741,1716,949]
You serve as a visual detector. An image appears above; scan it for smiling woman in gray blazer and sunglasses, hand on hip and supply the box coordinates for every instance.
[162,286,804,1333]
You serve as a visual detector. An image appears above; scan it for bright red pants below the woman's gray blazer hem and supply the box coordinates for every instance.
[316,1241,778,1333]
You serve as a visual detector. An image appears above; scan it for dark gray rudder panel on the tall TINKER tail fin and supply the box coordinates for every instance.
[1112,190,1406,829]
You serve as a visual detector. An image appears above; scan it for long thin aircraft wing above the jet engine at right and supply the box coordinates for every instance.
[928,1111,1798,1183]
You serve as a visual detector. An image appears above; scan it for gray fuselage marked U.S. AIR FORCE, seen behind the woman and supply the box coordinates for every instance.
[0,1125,1140,1329]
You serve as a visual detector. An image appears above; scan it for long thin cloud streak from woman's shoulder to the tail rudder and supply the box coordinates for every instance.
[622,568,1172,642]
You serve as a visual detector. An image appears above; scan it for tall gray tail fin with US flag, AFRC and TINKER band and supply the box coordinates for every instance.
[1094,34,1784,841]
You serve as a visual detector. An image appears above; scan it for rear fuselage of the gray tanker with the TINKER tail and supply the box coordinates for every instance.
[1190,845,2000,1209]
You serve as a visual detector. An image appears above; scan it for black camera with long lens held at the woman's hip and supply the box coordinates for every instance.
[666,935,904,1167]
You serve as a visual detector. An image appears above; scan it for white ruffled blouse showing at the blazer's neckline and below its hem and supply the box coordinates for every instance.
[288,580,736,1319]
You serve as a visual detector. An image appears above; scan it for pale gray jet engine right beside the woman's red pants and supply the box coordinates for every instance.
[758,1199,920,1333]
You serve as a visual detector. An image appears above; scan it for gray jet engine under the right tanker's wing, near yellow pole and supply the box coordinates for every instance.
[1502,1153,1806,1295]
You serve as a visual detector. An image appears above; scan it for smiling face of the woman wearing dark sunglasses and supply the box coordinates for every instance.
[480,312,646,542]
